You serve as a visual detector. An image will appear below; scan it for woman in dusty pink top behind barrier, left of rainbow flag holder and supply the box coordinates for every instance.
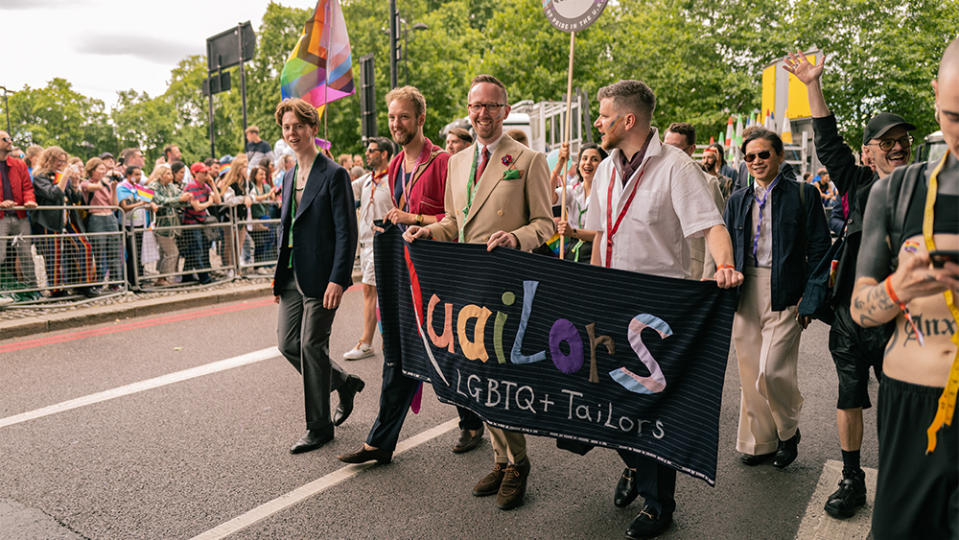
[80,158,123,289]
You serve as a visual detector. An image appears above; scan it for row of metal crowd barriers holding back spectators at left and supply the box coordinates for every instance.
[0,203,280,308]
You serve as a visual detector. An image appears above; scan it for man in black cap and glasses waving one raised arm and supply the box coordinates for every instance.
[785,52,916,519]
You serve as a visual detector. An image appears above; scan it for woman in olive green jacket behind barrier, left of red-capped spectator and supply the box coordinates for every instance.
[147,166,193,287]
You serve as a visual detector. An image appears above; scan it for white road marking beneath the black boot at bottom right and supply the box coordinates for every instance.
[796,459,877,540]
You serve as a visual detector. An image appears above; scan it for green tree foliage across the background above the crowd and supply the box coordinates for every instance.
[3,0,959,162]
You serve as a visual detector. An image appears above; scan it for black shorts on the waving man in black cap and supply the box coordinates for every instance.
[829,306,892,409]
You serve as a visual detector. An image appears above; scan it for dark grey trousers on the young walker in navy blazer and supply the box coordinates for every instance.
[277,278,348,431]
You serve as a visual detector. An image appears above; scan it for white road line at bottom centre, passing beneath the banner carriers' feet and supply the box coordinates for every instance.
[192,418,459,540]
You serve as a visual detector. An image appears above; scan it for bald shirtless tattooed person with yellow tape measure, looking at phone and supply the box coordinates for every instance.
[850,40,959,540]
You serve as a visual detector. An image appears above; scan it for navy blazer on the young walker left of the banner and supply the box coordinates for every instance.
[273,154,357,298]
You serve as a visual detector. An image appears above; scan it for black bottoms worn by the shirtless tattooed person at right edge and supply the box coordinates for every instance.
[872,377,959,540]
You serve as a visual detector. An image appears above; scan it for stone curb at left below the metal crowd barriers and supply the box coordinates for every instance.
[0,283,273,340]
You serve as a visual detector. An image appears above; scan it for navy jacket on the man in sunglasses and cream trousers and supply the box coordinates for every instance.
[723,175,830,311]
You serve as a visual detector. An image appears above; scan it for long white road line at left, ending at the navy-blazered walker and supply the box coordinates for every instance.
[0,347,280,428]
